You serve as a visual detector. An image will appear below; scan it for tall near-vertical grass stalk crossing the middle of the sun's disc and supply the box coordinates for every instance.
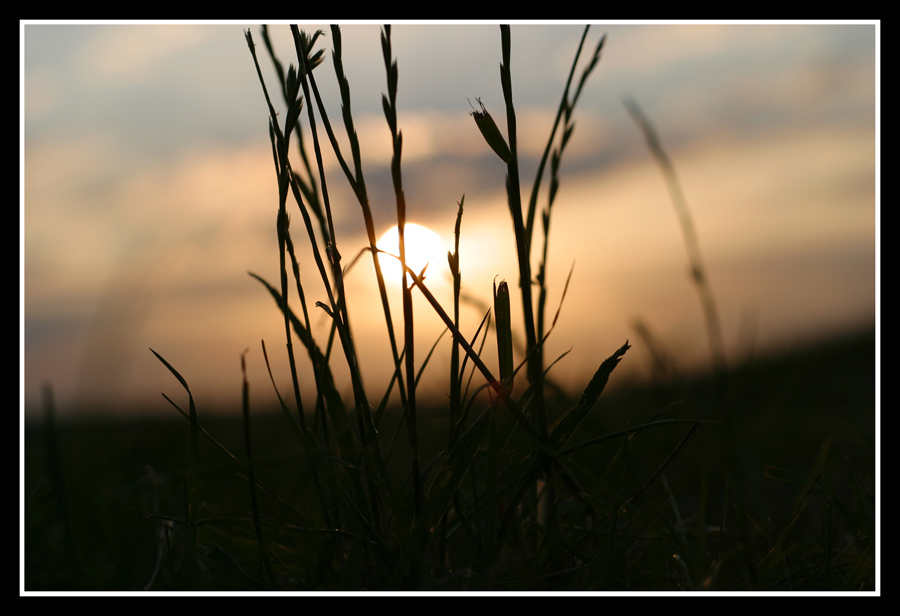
[381,25,423,518]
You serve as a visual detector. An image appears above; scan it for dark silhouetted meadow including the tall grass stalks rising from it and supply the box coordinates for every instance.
[23,27,877,592]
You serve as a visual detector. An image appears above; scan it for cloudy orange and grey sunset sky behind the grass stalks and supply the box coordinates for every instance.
[20,22,880,416]
